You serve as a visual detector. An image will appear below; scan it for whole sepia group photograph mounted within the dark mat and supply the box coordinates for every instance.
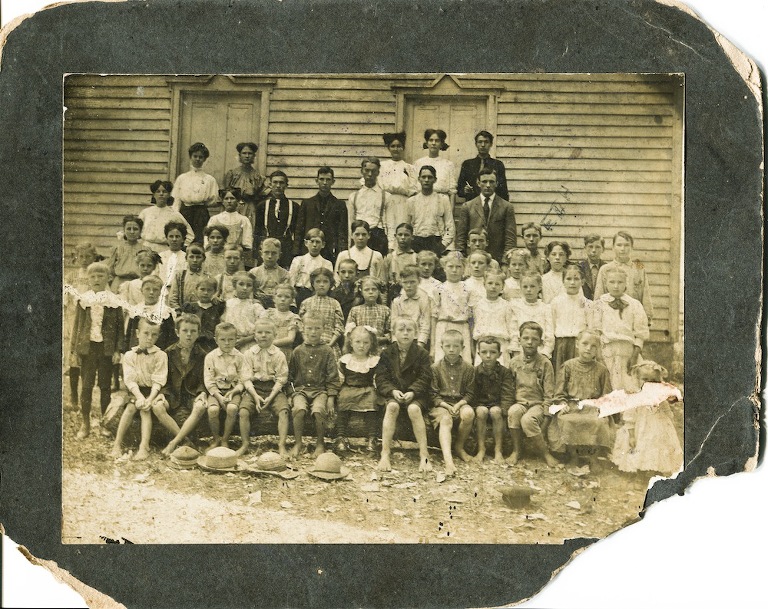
[61,73,685,544]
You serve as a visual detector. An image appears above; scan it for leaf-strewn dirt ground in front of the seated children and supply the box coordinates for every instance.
[62,402,682,544]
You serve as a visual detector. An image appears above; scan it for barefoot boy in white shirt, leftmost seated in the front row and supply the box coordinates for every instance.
[110,317,168,461]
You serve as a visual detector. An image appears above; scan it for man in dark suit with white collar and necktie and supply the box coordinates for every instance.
[456,167,517,264]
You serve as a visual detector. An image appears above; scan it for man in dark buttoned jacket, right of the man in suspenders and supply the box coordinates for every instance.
[294,167,349,264]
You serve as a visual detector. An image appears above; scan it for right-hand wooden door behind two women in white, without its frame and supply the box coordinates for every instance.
[405,97,488,167]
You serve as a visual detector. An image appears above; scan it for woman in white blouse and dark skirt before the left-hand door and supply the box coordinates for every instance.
[171,142,219,243]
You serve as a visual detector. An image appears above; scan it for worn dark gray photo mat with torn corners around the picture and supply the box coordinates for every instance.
[0,0,763,607]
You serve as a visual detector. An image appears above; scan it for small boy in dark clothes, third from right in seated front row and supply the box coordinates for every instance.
[470,336,515,463]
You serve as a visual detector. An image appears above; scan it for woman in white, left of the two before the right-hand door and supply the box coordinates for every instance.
[379,131,419,250]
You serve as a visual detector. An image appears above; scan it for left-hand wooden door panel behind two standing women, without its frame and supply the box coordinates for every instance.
[176,92,261,184]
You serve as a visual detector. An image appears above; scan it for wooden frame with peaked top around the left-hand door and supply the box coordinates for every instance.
[168,75,277,180]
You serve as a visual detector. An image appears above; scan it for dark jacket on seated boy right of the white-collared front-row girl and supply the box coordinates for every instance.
[375,341,432,407]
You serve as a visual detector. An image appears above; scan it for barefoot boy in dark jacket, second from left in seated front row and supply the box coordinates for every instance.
[160,316,207,456]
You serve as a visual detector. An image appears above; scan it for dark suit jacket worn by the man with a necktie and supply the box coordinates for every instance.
[456,195,517,264]
